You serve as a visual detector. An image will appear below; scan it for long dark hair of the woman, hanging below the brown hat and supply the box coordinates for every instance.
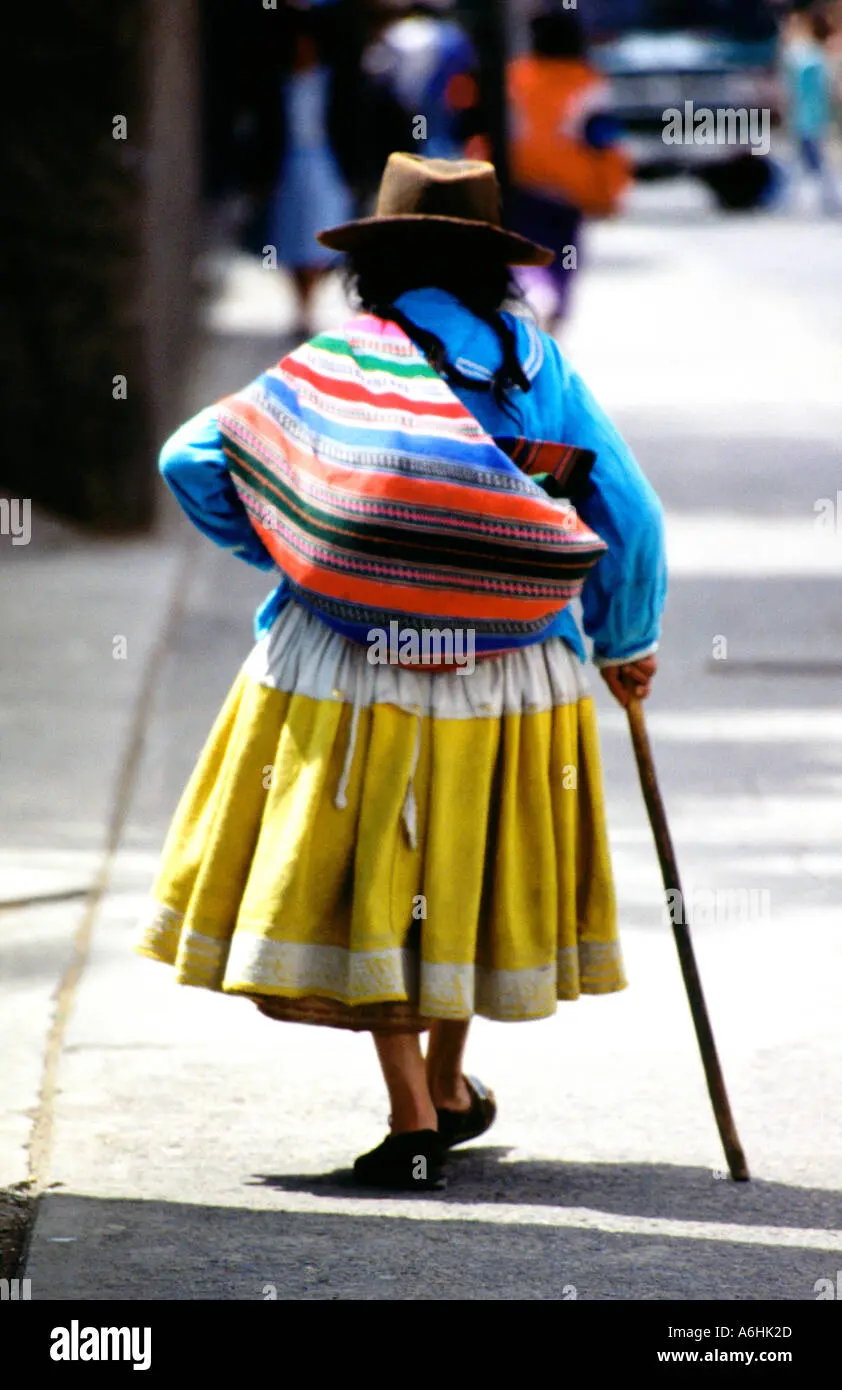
[346,222,532,410]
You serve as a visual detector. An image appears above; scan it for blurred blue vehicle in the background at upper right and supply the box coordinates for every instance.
[579,0,782,209]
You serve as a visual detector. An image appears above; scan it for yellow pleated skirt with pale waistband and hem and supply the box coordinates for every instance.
[138,603,625,1031]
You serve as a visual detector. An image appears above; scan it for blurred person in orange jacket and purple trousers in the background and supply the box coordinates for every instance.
[506,10,632,332]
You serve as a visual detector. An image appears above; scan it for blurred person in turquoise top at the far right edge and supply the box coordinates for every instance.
[784,11,841,214]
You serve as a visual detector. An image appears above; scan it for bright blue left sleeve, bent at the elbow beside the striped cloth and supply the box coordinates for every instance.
[158,406,275,570]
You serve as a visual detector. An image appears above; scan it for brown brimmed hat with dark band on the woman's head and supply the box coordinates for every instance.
[317,154,556,265]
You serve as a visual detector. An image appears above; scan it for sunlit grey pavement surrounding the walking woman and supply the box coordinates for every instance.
[0,192,842,1301]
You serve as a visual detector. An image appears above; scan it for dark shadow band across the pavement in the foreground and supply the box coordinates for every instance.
[25,1167,842,1301]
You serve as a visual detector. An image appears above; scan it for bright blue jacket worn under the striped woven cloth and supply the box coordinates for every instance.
[160,289,667,666]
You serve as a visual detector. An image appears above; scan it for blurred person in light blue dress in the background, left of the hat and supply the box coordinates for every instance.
[267,4,354,338]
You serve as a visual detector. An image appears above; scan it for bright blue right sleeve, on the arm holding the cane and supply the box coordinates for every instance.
[559,354,667,666]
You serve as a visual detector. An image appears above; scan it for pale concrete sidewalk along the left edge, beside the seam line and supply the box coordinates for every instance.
[0,494,192,1273]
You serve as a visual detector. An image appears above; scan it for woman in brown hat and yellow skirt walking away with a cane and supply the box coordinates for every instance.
[139,154,666,1191]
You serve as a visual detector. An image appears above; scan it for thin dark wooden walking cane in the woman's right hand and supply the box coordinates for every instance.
[628,699,750,1183]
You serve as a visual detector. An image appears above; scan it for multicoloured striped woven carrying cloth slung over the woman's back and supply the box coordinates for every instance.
[218,316,607,652]
